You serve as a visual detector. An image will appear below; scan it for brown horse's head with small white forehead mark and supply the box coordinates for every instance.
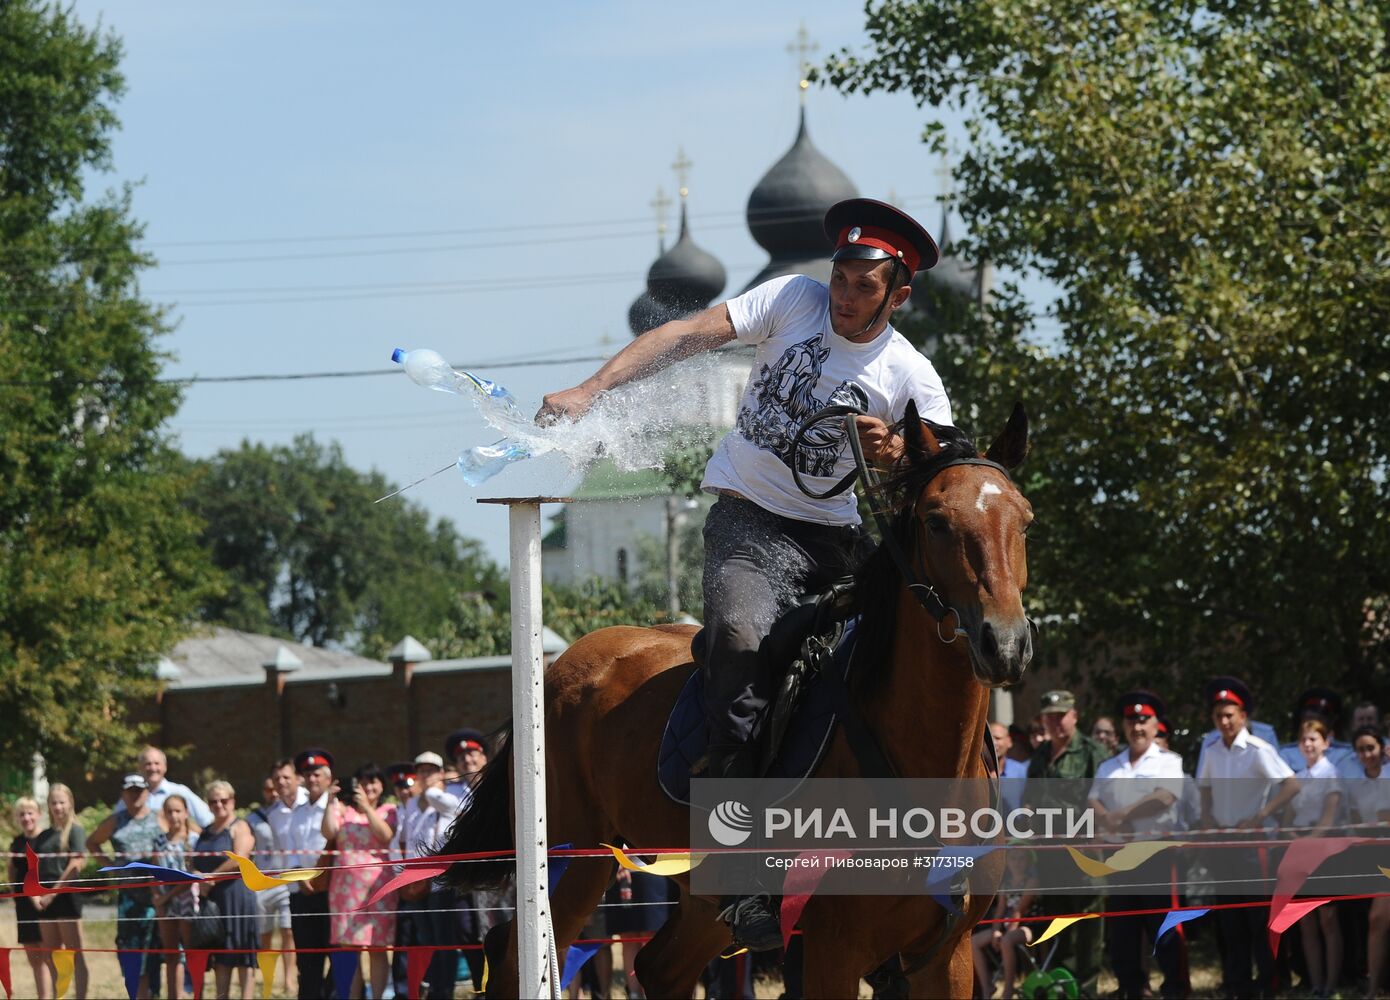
[894,402,1033,687]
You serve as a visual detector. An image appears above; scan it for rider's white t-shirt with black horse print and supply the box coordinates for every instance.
[701,274,951,524]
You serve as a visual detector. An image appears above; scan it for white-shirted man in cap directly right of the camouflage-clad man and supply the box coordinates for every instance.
[1088,691,1184,1000]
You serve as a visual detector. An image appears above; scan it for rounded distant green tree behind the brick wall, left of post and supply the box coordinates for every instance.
[192,435,506,656]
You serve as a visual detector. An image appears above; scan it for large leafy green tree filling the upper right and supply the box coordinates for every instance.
[821,0,1390,712]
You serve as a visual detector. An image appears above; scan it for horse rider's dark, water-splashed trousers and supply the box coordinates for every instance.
[705,497,866,750]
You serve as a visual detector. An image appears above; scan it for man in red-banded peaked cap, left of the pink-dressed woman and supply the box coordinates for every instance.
[284,747,334,1000]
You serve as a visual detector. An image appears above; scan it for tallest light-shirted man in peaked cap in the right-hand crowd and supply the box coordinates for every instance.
[1197,677,1298,996]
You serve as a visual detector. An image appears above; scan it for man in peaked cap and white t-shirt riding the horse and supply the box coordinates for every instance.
[537,199,951,950]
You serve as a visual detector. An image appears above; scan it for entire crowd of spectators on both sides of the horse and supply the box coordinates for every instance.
[8,689,1390,1000]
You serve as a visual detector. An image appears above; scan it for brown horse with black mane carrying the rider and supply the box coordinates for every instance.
[439,405,1033,997]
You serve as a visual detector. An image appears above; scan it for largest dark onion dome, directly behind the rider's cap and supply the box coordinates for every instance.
[748,108,859,260]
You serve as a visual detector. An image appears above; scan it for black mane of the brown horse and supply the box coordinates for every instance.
[849,420,980,695]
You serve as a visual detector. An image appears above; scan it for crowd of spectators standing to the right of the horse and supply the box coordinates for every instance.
[974,676,1390,997]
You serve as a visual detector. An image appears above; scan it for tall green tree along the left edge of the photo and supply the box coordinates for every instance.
[0,0,213,769]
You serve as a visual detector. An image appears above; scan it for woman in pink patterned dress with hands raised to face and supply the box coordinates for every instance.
[322,764,396,997]
